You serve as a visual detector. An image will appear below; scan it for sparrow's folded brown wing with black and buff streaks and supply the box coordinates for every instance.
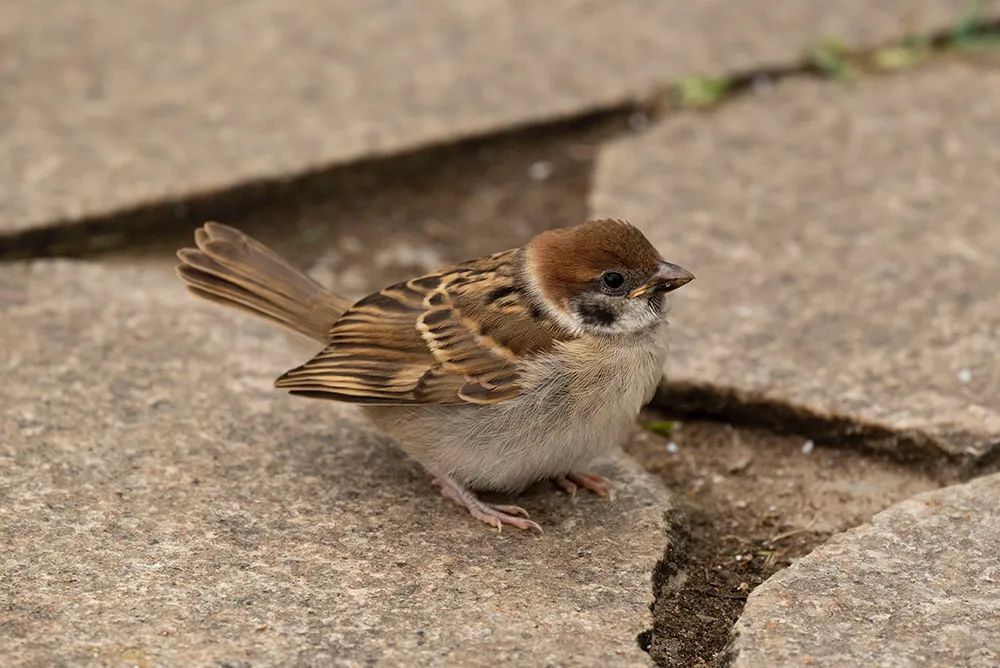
[275,250,568,404]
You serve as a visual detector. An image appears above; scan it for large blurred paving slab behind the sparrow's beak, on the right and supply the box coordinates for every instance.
[592,62,1000,458]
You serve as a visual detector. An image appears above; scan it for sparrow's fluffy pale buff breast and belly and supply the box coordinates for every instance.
[366,326,665,491]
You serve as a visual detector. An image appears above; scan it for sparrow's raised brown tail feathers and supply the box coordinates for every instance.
[177,223,351,343]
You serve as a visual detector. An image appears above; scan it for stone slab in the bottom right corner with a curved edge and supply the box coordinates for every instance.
[731,475,1000,668]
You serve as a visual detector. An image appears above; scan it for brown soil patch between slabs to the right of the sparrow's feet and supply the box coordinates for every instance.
[627,412,945,666]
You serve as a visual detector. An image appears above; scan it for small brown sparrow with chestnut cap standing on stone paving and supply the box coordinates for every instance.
[177,220,694,531]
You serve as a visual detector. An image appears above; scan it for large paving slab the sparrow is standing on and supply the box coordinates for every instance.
[0,261,668,666]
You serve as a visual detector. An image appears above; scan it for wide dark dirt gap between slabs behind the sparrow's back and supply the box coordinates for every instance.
[0,107,634,264]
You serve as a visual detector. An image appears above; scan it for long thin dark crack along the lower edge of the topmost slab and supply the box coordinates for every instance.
[0,17,1000,262]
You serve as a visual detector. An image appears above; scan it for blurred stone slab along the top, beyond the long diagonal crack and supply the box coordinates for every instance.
[0,0,1000,237]
